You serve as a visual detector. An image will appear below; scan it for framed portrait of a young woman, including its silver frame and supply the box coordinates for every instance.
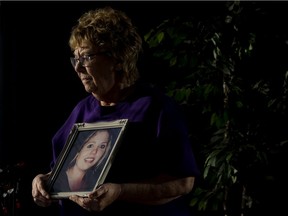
[47,119,128,199]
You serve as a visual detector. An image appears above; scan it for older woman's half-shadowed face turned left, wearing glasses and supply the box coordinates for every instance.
[74,43,117,101]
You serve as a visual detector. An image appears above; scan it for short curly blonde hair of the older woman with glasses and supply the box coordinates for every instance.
[69,7,142,87]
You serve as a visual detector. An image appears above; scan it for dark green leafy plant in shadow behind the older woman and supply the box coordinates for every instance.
[144,1,288,215]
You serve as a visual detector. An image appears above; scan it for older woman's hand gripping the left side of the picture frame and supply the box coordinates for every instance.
[32,172,52,207]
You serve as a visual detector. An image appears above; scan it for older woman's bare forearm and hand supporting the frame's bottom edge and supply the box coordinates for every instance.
[69,176,195,211]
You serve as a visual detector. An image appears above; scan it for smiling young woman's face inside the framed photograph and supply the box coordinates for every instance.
[76,131,109,170]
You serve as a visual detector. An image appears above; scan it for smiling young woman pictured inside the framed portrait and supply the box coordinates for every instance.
[53,129,112,192]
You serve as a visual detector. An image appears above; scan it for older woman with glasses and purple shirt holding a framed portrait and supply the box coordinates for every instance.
[32,7,198,216]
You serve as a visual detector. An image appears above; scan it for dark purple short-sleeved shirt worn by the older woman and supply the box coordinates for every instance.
[51,84,199,216]
